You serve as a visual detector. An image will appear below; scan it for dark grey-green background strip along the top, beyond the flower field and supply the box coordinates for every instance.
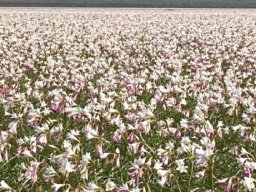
[0,0,256,8]
